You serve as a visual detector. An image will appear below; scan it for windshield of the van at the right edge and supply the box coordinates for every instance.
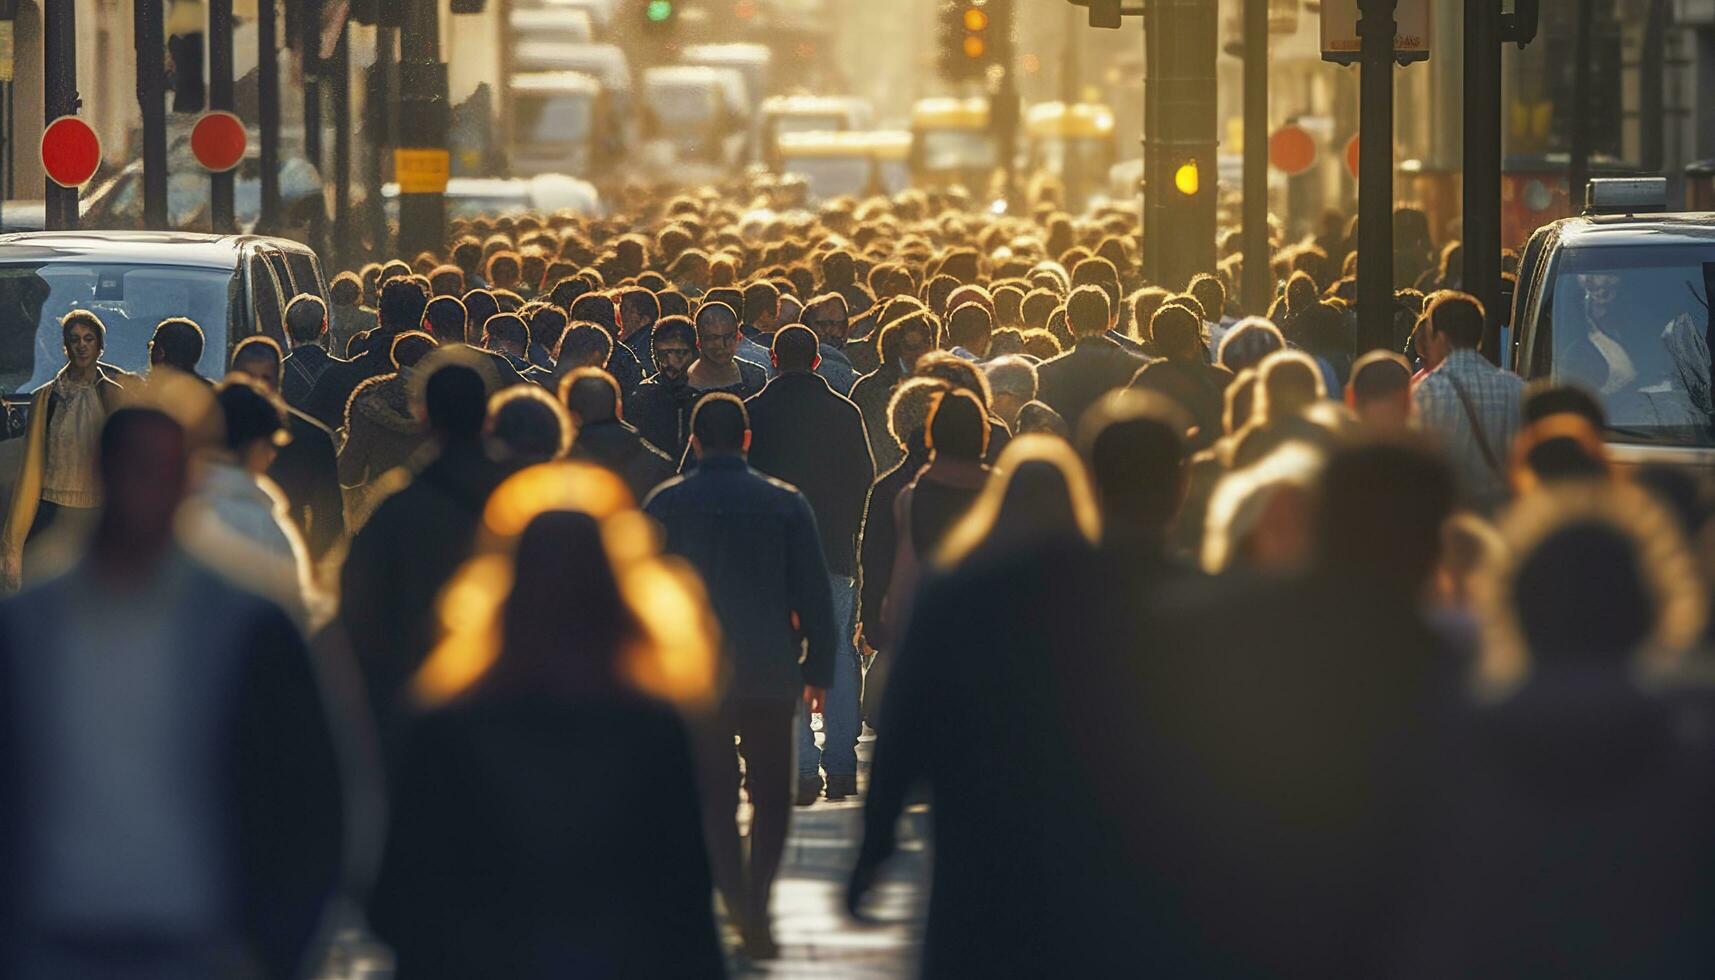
[1550,244,1715,446]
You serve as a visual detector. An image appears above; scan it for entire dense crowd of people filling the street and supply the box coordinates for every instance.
[0,181,1715,980]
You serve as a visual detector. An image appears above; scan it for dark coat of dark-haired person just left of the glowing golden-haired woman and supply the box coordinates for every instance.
[340,443,504,723]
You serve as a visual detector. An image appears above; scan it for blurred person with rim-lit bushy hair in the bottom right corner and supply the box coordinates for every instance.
[1413,484,1715,978]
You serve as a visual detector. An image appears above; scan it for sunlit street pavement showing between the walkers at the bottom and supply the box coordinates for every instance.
[316,735,930,980]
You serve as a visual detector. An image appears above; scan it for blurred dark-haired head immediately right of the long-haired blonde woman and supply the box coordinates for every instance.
[1079,390,1188,539]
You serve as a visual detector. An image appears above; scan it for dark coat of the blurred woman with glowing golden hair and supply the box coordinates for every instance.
[370,692,725,980]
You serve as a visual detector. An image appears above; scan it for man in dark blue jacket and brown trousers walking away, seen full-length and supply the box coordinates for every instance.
[643,393,837,959]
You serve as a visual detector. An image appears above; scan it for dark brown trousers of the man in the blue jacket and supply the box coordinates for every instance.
[698,700,797,927]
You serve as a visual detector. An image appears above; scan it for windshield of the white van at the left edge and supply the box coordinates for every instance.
[0,263,233,395]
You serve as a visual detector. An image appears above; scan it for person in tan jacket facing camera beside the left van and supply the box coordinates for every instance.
[0,311,123,592]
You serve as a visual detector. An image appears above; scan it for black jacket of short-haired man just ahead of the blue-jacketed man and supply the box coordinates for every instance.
[744,372,875,577]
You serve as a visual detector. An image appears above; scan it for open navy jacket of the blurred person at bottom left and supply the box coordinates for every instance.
[0,560,345,980]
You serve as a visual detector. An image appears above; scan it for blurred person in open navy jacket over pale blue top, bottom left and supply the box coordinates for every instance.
[0,408,341,980]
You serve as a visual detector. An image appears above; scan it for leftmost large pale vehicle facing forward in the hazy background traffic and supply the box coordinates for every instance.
[506,72,624,177]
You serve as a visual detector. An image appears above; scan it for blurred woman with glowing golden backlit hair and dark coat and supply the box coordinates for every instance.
[370,463,725,980]
